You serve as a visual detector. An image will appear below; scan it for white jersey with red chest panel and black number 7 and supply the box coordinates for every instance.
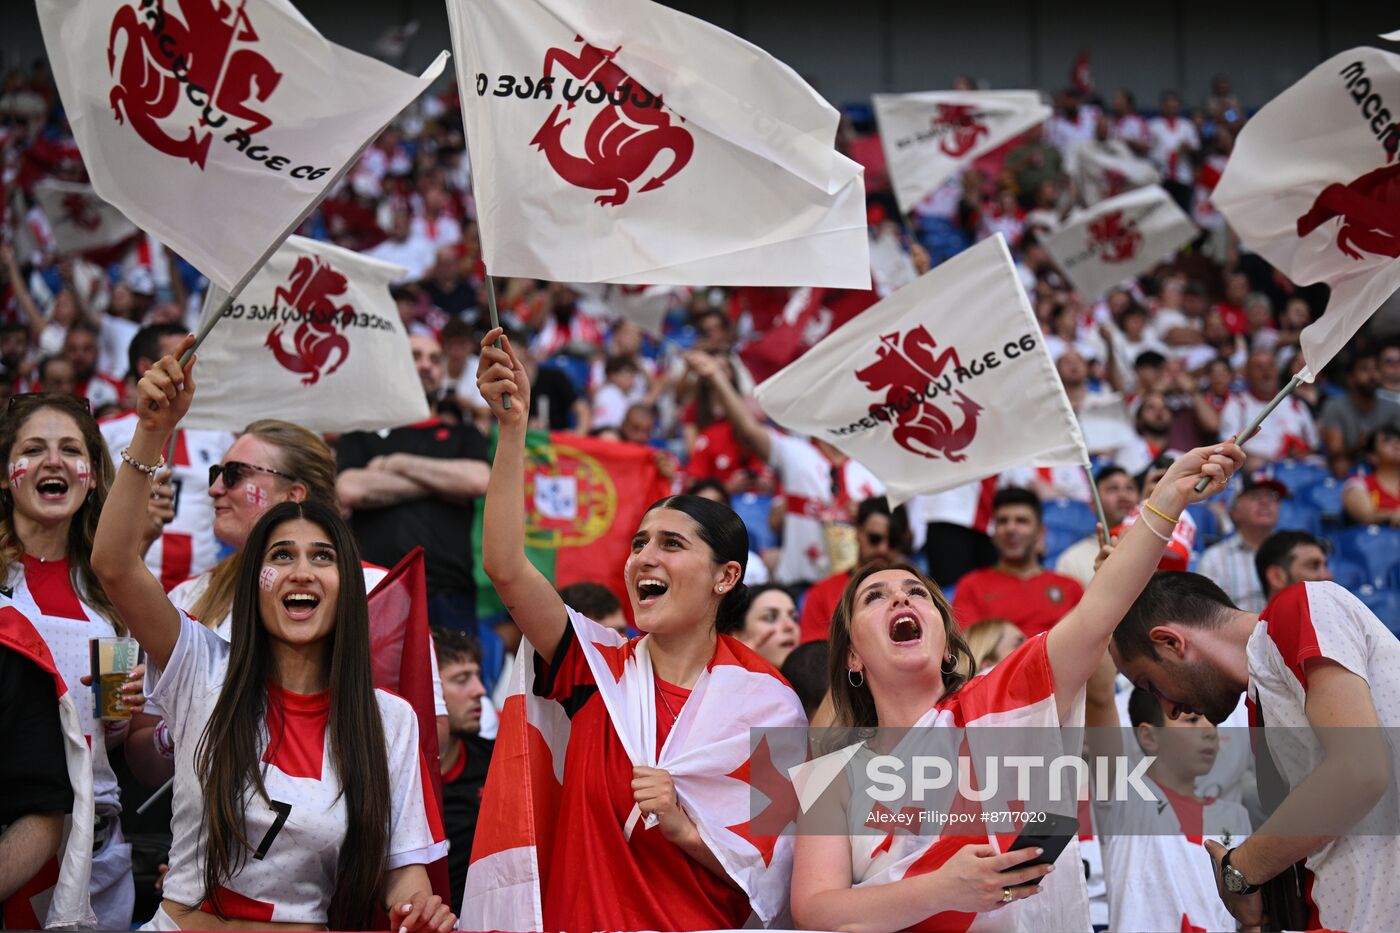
[146,612,447,923]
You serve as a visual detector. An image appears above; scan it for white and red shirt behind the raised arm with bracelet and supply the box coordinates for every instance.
[101,412,234,591]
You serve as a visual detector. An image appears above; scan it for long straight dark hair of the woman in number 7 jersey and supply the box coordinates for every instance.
[195,502,389,930]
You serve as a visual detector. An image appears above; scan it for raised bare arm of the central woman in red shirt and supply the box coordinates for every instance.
[476,328,568,661]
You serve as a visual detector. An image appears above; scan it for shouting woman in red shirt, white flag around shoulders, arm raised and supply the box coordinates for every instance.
[462,329,806,930]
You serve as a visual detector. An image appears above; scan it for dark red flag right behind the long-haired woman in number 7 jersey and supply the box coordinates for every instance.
[370,548,452,904]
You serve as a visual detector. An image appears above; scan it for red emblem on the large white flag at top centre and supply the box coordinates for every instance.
[531,36,694,205]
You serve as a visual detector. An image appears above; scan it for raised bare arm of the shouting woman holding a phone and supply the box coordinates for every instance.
[1047,443,1245,716]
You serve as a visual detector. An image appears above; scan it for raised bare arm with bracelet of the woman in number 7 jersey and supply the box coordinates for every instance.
[92,336,195,668]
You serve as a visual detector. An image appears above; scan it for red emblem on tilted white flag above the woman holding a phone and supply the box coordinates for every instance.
[855,326,981,464]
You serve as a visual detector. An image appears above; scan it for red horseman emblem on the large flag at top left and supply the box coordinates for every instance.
[106,0,281,168]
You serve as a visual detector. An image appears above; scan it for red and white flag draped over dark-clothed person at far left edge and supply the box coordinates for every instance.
[0,598,97,930]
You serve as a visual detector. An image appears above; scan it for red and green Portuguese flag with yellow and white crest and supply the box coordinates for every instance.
[472,429,671,622]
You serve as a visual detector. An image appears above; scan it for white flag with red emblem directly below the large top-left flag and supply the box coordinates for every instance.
[183,237,428,431]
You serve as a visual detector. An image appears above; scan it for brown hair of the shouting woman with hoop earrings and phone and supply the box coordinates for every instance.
[827,558,976,728]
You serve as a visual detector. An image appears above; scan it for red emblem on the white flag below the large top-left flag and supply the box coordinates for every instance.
[265,256,354,385]
